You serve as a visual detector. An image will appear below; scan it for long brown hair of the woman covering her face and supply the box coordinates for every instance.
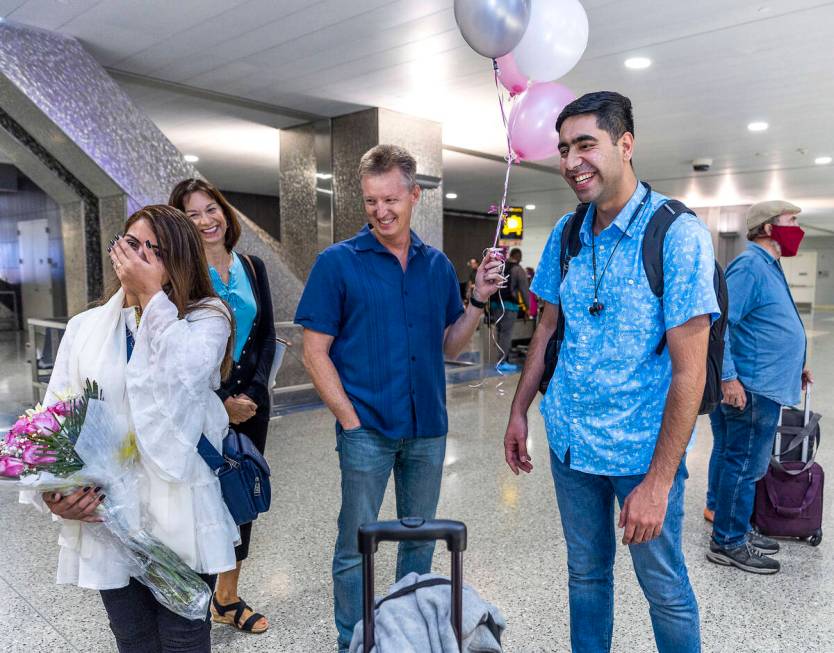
[108,204,234,379]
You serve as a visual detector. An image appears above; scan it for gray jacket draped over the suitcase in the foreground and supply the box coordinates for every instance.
[350,573,507,653]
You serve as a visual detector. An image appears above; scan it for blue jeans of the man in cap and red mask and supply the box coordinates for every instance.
[710,392,782,549]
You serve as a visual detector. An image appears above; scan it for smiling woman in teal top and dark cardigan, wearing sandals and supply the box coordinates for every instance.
[168,179,275,633]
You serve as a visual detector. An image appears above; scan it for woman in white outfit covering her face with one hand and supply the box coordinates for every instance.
[26,205,239,653]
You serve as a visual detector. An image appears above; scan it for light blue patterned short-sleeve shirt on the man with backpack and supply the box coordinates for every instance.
[532,184,719,476]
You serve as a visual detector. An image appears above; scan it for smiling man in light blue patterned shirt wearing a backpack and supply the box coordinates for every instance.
[504,91,719,653]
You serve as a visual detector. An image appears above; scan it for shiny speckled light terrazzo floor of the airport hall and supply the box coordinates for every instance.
[0,313,834,653]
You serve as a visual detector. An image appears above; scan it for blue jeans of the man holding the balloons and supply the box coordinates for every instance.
[333,428,446,650]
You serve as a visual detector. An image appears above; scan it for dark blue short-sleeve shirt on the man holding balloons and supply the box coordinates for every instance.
[295,226,463,438]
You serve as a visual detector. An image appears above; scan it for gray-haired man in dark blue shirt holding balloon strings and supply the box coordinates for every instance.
[295,145,502,651]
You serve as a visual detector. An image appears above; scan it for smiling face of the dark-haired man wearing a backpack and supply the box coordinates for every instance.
[559,114,634,204]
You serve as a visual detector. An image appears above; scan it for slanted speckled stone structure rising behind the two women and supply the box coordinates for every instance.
[0,21,301,320]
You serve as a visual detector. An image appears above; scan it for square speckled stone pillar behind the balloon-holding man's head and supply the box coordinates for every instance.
[332,108,443,249]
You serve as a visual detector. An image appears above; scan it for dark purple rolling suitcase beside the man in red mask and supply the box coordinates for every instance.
[753,384,825,546]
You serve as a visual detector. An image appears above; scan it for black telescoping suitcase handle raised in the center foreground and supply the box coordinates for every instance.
[359,517,466,653]
